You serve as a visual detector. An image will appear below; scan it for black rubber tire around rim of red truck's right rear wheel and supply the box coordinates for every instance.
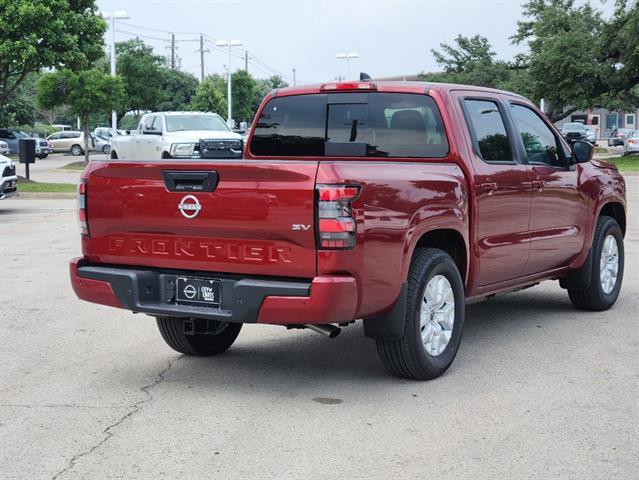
[377,248,465,380]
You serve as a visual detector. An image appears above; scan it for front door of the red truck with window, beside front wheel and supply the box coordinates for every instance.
[511,103,588,275]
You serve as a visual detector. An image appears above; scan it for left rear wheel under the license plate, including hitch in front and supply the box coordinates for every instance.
[157,317,242,357]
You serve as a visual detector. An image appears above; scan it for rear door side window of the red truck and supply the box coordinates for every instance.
[464,99,513,162]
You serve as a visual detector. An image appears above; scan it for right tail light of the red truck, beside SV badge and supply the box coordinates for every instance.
[316,185,360,250]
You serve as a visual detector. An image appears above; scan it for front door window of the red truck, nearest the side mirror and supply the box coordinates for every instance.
[512,105,565,168]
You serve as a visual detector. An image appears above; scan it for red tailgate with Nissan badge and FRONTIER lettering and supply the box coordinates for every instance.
[83,160,318,278]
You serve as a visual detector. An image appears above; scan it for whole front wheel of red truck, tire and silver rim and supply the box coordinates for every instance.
[568,215,624,311]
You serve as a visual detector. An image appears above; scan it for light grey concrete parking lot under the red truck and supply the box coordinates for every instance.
[0,175,639,480]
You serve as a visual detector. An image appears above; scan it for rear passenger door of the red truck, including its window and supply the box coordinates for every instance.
[460,96,531,287]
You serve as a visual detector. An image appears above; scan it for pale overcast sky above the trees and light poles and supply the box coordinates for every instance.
[97,0,613,84]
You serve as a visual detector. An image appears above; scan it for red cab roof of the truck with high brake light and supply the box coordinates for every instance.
[272,80,524,98]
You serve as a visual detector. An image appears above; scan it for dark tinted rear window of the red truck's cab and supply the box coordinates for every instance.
[250,92,449,158]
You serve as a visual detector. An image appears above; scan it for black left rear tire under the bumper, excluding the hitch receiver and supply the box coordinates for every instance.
[156,317,242,357]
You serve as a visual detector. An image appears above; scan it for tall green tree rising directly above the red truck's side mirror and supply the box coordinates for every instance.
[513,0,608,122]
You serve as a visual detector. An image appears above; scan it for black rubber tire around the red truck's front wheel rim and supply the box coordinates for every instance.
[568,215,625,311]
